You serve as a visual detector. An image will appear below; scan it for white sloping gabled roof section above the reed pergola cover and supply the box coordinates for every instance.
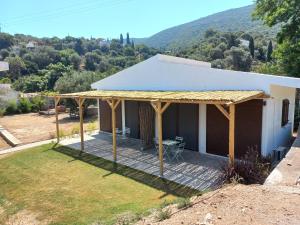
[92,54,300,93]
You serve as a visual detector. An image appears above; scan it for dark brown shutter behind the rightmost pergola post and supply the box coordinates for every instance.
[206,100,263,158]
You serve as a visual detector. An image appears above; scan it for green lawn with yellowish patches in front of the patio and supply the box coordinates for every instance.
[0,144,197,224]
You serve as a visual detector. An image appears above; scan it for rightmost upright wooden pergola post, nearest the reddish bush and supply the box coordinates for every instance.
[229,104,235,165]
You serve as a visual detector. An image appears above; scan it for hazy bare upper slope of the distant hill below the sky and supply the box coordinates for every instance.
[135,5,278,49]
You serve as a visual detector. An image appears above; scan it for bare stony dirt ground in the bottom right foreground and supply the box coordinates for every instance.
[138,185,300,225]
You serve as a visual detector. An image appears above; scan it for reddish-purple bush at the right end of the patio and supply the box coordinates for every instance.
[224,148,271,184]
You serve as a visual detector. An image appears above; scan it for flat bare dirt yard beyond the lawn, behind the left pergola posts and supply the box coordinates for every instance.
[0,113,98,148]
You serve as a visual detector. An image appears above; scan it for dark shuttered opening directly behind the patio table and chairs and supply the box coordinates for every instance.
[163,104,199,151]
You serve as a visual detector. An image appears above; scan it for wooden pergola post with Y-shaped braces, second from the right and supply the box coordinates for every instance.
[151,102,170,177]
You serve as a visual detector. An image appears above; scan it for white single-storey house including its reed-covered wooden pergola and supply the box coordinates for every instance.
[57,54,300,174]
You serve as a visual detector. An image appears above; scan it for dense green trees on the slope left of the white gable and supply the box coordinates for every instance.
[0,33,158,92]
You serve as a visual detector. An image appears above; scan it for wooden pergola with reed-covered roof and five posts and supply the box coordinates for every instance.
[55,90,268,176]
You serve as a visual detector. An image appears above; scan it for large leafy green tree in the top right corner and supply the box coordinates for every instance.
[253,0,300,76]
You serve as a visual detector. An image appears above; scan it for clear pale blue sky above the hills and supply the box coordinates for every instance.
[0,0,253,38]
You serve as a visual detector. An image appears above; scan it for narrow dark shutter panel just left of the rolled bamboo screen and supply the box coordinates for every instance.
[125,101,140,139]
